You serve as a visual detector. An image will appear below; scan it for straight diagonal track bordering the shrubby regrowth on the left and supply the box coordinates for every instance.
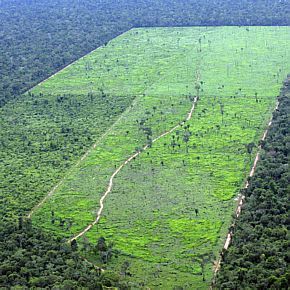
[27,97,138,219]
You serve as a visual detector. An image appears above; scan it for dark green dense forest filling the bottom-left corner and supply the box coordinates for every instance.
[0,221,104,289]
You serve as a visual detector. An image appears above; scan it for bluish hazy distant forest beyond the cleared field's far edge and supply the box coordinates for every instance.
[0,0,290,106]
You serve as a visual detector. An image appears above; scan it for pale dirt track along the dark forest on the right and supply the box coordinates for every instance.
[211,101,279,289]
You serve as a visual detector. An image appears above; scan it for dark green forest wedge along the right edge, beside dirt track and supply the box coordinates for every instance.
[217,77,290,289]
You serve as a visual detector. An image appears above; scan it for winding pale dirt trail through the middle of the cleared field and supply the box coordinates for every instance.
[67,94,199,243]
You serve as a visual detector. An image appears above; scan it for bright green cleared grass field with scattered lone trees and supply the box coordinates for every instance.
[31,27,290,289]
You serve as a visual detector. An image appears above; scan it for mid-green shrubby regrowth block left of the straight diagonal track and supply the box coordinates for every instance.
[0,94,133,219]
